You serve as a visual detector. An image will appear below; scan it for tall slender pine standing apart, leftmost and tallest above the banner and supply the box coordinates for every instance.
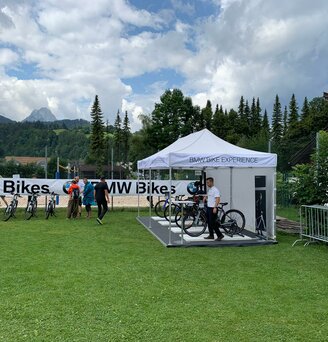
[90,95,105,176]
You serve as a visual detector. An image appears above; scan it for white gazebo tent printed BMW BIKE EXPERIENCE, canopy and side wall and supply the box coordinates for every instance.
[138,129,277,246]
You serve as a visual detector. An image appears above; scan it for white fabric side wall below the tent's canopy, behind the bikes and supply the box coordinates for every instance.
[206,168,276,239]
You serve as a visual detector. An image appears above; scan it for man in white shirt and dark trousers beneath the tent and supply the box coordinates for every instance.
[205,177,224,241]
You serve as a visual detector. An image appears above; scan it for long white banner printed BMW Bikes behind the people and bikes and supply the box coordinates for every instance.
[0,178,194,196]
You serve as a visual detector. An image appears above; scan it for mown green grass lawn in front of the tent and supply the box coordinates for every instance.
[0,207,328,342]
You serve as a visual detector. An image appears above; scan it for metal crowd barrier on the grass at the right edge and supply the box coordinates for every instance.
[293,205,328,246]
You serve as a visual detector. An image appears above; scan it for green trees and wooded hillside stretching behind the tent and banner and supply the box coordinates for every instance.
[0,89,328,186]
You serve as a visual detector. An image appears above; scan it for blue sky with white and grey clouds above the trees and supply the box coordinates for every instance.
[0,0,328,130]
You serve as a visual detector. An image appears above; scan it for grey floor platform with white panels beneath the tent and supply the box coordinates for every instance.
[137,216,277,247]
